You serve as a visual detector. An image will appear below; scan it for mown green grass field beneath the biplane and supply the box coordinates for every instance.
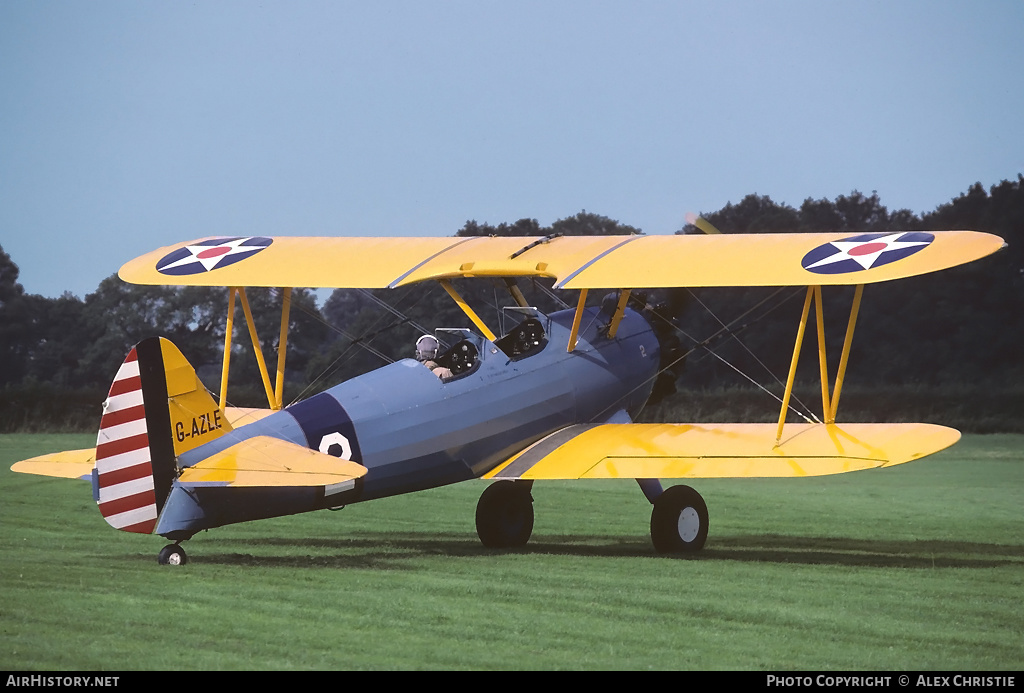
[0,434,1024,670]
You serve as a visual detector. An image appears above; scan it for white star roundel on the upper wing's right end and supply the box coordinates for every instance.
[800,231,935,274]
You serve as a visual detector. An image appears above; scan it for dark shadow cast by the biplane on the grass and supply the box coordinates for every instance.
[172,532,1024,570]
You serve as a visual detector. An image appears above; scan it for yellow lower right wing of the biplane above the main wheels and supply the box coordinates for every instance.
[484,424,959,479]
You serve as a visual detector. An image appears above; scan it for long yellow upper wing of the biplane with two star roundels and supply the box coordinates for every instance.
[119,231,1005,289]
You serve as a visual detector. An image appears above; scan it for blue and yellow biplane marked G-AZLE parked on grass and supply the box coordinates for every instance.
[12,231,1004,564]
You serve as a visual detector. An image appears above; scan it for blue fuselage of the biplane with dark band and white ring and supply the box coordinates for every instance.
[156,308,659,538]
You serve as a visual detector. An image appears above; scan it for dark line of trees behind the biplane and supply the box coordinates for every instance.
[0,175,1024,431]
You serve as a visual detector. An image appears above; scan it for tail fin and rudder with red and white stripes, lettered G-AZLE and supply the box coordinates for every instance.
[93,337,231,534]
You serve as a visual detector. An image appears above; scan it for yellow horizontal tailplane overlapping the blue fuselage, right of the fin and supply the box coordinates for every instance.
[178,436,367,486]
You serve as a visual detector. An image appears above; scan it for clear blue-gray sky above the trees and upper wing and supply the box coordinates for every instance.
[0,0,1024,297]
